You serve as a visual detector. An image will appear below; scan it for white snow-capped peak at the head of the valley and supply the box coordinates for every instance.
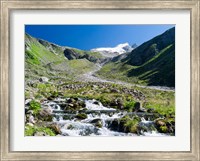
[91,43,134,57]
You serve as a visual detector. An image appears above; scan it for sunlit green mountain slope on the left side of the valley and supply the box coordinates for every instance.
[25,34,104,79]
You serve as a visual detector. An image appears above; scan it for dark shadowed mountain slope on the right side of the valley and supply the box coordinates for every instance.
[98,28,175,87]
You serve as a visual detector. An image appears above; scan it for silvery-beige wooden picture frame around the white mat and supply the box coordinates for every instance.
[0,0,200,161]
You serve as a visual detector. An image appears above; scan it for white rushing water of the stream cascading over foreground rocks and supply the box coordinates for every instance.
[43,98,166,136]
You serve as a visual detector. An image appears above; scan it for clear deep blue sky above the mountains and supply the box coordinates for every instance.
[25,25,174,50]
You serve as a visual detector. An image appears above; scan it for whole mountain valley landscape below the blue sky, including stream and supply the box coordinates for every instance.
[25,28,175,136]
